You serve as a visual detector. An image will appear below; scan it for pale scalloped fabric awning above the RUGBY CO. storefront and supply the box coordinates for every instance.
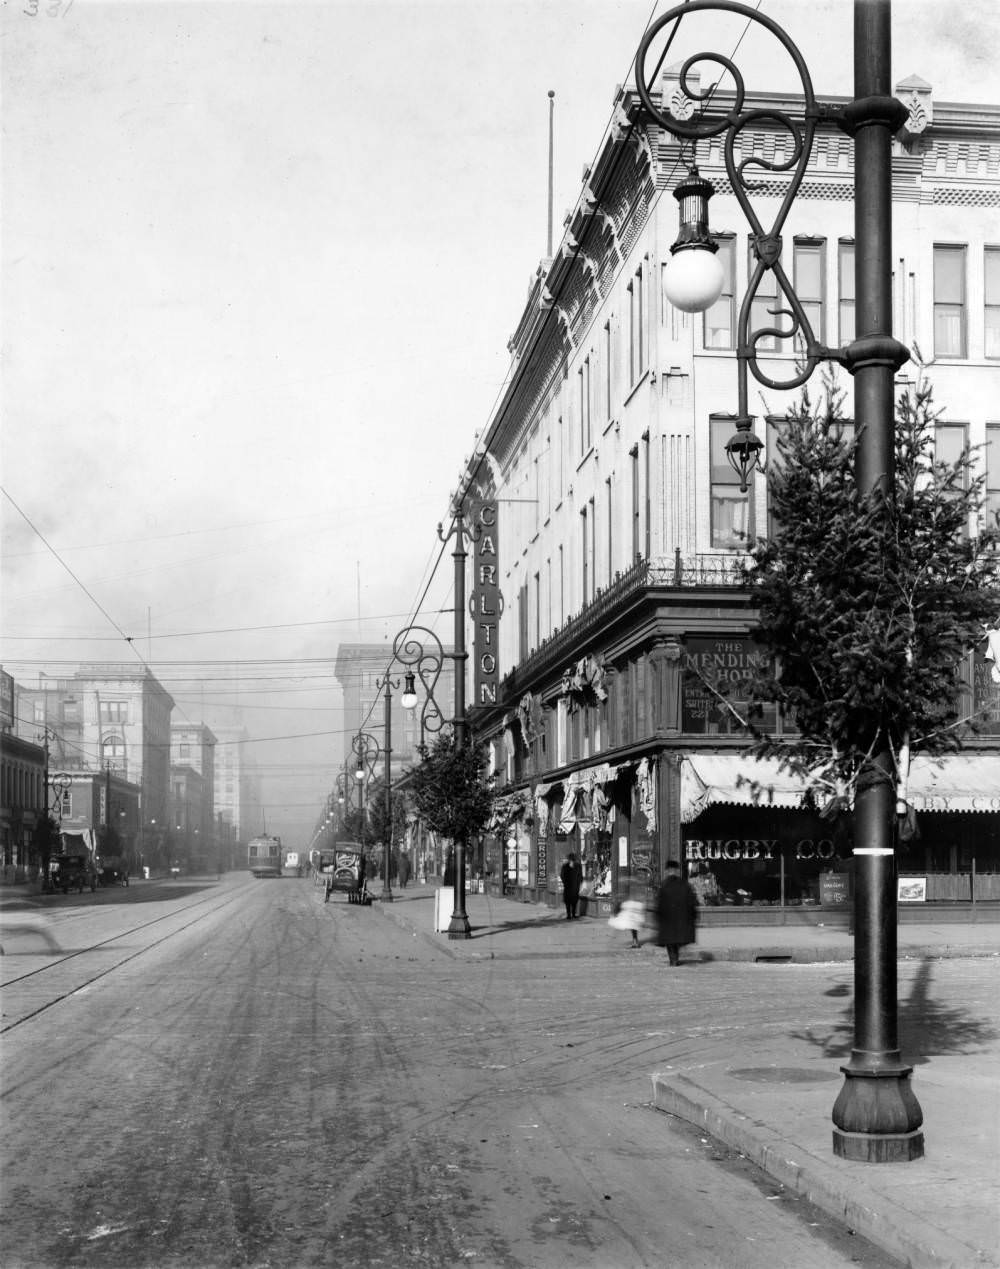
[680,754,1000,824]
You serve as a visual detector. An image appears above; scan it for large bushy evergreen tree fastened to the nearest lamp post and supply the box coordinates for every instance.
[746,370,1000,812]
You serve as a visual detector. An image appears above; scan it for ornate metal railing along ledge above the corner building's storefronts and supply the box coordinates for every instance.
[500,549,746,700]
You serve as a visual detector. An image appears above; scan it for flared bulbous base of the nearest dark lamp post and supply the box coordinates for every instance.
[832,1066,924,1164]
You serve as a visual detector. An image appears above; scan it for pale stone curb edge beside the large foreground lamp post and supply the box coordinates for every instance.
[651,1071,1000,1269]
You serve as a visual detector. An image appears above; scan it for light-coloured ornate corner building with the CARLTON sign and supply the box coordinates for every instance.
[467,70,1000,923]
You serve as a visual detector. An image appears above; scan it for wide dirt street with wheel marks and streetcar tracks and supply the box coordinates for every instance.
[1,876,908,1269]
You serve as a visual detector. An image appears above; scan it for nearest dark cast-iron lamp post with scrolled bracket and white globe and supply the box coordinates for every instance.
[636,0,924,1162]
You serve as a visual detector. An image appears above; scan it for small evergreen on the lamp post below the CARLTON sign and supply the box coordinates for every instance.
[409,735,494,937]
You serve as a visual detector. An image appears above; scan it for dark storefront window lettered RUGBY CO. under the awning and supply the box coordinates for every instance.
[683,806,850,907]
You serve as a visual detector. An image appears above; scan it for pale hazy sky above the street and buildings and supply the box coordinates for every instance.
[0,0,1000,839]
